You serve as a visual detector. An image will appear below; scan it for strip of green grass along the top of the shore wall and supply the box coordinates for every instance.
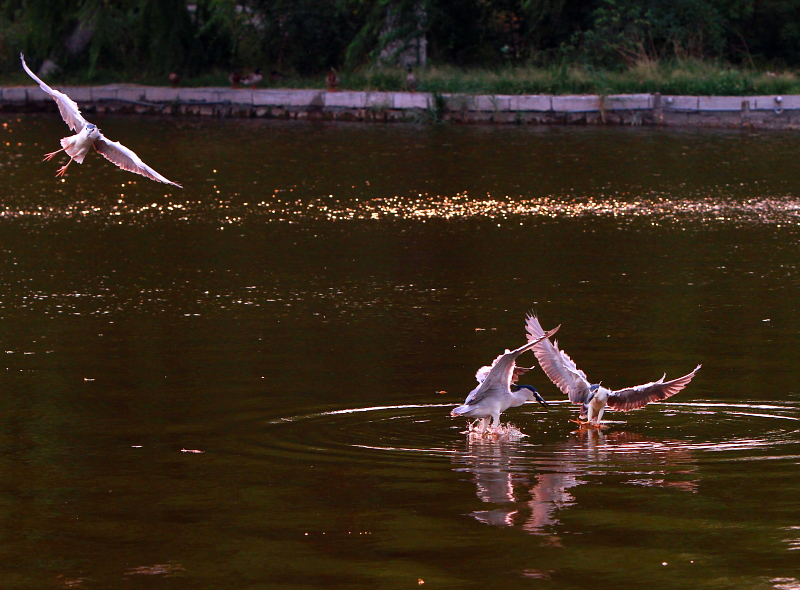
[6,60,800,96]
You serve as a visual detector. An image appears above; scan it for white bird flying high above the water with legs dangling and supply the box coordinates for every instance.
[19,53,183,188]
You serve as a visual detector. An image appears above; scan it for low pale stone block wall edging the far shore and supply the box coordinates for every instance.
[0,84,800,129]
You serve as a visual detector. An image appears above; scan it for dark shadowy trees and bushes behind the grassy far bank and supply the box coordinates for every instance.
[0,0,800,81]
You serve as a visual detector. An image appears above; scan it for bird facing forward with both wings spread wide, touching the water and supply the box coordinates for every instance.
[525,314,702,427]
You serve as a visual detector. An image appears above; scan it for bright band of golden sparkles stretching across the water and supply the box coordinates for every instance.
[0,187,800,225]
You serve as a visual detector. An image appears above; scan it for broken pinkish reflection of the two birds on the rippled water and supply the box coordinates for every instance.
[453,429,697,545]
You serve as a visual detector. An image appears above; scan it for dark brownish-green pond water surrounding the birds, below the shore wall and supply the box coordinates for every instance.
[0,115,800,590]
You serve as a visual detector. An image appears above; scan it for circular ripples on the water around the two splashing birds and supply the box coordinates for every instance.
[255,402,800,467]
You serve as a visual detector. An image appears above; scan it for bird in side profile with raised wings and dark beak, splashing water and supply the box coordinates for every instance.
[450,326,561,434]
